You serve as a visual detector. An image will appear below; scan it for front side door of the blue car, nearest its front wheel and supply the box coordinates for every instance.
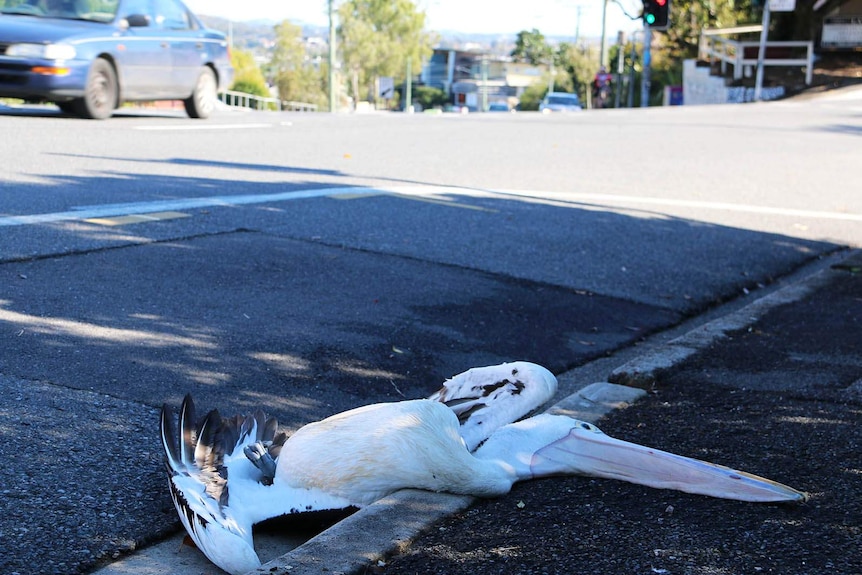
[117,0,171,100]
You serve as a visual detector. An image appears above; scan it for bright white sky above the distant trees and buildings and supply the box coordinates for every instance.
[185,0,641,38]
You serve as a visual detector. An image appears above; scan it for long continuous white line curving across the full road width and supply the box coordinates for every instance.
[0,186,862,227]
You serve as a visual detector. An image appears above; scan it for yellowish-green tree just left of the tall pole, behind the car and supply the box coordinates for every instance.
[270,20,329,109]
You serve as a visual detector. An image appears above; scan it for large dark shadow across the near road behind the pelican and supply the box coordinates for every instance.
[0,169,836,573]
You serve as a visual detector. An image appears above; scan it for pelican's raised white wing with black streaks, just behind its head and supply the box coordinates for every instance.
[428,361,557,451]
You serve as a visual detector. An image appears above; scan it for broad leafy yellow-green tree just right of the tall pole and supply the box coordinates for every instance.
[338,0,431,106]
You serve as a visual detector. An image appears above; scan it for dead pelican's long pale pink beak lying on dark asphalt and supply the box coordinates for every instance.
[530,420,808,502]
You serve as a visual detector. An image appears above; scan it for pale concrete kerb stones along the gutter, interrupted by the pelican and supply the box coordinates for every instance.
[251,251,862,575]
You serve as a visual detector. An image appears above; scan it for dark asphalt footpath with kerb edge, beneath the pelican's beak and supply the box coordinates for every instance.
[260,252,862,575]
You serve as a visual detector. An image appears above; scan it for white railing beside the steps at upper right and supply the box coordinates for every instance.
[698,25,814,84]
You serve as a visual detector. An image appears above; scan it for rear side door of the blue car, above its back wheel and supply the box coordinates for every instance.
[154,0,206,99]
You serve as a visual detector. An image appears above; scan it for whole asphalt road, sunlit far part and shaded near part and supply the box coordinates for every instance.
[0,86,862,573]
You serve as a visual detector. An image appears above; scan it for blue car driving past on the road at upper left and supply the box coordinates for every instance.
[0,0,233,119]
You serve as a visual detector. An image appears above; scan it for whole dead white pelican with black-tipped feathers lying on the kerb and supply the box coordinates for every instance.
[161,362,806,575]
